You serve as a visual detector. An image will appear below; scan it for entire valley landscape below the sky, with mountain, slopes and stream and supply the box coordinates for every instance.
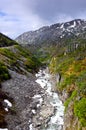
[0,19,86,130]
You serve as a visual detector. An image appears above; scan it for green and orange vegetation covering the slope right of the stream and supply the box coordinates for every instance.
[49,38,86,127]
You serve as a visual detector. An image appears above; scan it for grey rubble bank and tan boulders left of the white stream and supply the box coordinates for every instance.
[2,71,54,130]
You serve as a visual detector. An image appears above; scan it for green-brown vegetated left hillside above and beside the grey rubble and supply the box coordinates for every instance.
[0,34,40,128]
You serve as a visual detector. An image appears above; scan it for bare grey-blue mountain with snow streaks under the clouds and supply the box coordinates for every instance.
[15,19,86,45]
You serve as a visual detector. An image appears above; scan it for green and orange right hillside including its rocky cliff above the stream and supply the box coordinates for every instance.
[49,38,86,130]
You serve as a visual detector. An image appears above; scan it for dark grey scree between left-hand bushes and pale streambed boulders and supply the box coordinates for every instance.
[2,71,43,130]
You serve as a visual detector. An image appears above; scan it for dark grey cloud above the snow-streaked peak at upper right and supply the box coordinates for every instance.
[30,0,86,21]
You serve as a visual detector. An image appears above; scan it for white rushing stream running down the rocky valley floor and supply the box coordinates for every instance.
[36,69,64,130]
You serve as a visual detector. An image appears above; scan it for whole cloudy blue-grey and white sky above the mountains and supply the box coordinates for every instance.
[0,0,86,38]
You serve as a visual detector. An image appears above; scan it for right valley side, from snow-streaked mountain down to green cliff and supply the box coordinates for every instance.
[16,19,86,130]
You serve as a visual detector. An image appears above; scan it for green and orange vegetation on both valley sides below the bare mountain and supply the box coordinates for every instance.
[0,24,86,127]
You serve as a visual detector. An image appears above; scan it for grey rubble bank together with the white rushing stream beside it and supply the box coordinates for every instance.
[2,70,64,130]
